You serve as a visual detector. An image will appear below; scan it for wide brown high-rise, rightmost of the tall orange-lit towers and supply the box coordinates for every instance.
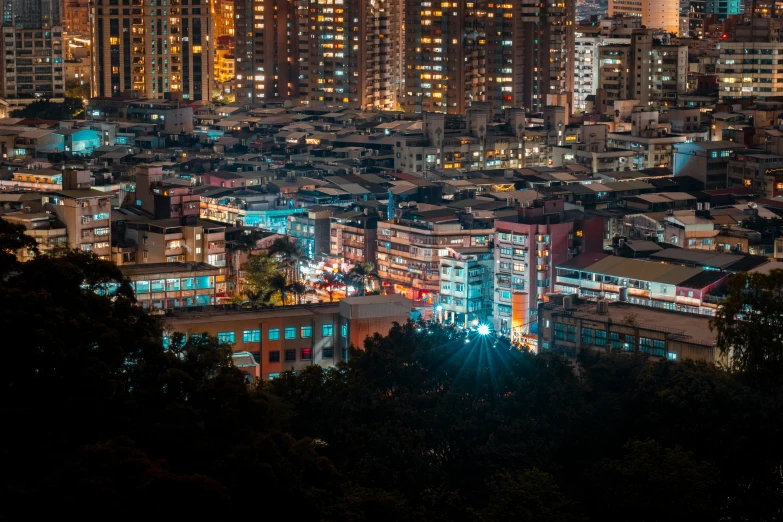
[404,0,574,114]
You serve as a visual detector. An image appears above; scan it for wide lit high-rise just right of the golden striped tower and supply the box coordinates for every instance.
[234,0,402,110]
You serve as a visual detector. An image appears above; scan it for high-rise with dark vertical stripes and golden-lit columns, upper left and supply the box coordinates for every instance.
[90,0,214,100]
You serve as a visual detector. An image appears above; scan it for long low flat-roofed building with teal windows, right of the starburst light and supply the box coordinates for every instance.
[538,297,727,365]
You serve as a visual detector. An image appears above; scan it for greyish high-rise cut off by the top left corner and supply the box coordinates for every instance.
[0,0,65,106]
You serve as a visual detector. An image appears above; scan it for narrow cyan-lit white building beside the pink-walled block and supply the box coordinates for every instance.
[436,247,495,326]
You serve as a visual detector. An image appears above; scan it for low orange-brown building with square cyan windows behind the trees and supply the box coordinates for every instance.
[165,296,411,379]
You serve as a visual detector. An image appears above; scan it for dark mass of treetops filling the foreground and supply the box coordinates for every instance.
[0,254,783,522]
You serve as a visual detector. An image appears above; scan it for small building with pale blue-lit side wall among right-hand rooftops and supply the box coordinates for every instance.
[672,141,745,190]
